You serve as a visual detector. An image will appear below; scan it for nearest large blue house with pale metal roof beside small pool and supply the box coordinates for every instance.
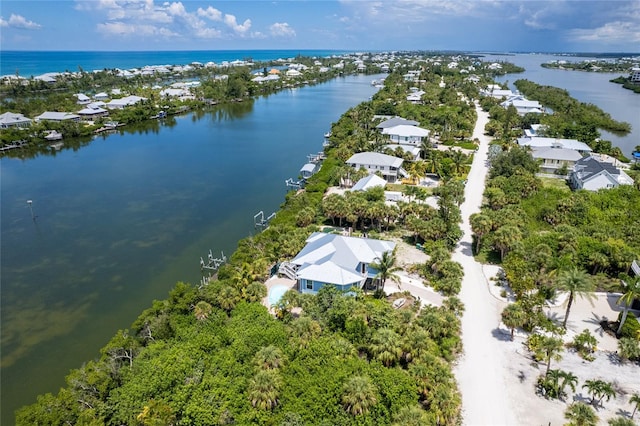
[280,232,396,294]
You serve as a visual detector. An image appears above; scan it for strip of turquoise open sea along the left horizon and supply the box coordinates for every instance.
[0,50,352,77]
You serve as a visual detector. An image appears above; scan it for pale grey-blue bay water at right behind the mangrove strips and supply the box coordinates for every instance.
[483,54,640,157]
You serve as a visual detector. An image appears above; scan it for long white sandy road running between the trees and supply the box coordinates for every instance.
[452,105,516,425]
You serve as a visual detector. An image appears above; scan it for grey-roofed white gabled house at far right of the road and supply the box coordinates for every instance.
[569,156,633,191]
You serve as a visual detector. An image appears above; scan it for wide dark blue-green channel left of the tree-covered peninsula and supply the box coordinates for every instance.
[0,76,379,424]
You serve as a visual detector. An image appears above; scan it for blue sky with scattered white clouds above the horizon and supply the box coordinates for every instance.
[0,0,640,52]
